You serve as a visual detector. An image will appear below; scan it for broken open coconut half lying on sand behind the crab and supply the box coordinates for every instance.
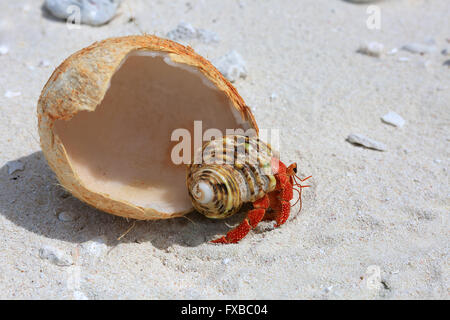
[37,36,258,219]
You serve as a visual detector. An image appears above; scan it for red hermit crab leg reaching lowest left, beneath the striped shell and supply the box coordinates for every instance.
[211,195,269,243]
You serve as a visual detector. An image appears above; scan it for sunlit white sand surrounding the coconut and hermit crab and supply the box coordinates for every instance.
[0,0,450,299]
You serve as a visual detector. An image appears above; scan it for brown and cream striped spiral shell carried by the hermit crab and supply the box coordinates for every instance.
[186,135,279,219]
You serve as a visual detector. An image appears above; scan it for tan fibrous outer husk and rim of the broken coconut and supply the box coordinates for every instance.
[37,35,258,220]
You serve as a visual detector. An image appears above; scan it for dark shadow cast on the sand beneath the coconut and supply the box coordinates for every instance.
[0,152,243,250]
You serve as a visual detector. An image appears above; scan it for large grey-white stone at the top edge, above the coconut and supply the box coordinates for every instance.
[45,0,121,26]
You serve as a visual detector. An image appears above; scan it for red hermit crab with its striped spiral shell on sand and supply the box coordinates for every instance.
[186,135,310,243]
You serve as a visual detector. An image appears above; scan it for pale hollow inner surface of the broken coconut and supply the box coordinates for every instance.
[43,50,253,219]
